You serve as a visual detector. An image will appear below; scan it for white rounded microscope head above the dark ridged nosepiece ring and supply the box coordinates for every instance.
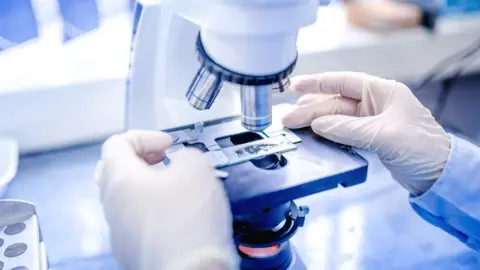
[169,0,318,76]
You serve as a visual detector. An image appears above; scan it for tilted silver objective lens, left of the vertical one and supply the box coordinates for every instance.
[186,67,223,110]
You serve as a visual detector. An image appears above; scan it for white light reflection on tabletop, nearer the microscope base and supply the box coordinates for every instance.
[302,217,334,270]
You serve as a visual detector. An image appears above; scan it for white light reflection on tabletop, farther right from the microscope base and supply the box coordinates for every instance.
[336,205,365,270]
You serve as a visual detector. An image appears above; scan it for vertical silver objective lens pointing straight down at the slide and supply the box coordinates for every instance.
[240,85,272,131]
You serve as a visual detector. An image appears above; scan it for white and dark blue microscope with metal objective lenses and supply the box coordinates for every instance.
[126,0,368,270]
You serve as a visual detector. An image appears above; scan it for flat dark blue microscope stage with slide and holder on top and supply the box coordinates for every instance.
[166,115,368,215]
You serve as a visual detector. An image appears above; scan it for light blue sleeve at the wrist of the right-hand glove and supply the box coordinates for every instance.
[410,135,480,252]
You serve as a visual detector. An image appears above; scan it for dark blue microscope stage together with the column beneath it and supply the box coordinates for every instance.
[166,116,368,270]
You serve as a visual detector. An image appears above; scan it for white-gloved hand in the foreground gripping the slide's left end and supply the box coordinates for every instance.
[95,131,237,270]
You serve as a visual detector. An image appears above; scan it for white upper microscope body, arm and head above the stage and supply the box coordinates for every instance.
[126,0,318,130]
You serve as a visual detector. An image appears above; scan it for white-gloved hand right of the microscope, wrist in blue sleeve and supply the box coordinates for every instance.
[283,72,450,195]
